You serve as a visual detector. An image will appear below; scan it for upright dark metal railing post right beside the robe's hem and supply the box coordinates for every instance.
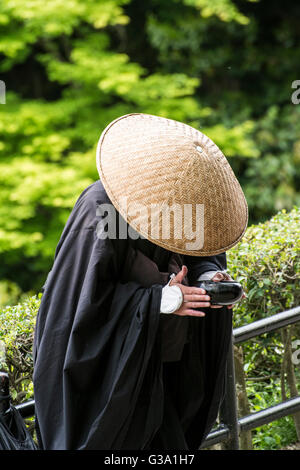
[220,338,240,450]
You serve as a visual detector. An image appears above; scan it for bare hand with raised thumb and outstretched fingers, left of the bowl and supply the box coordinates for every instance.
[169,265,211,317]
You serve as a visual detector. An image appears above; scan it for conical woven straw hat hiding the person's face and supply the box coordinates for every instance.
[97,113,248,256]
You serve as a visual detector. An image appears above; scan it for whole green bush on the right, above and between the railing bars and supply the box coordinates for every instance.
[228,207,300,449]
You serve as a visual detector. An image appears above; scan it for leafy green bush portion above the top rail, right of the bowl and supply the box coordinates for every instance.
[228,207,300,327]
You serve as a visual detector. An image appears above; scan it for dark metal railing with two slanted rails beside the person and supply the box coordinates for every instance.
[11,306,300,450]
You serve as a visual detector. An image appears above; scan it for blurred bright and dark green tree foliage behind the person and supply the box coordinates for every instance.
[0,0,300,296]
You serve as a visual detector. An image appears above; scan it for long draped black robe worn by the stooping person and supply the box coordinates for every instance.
[33,181,232,450]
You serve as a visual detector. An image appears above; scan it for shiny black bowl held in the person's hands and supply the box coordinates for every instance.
[195,281,243,305]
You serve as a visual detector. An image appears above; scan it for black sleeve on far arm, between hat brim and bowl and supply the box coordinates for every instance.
[184,253,227,283]
